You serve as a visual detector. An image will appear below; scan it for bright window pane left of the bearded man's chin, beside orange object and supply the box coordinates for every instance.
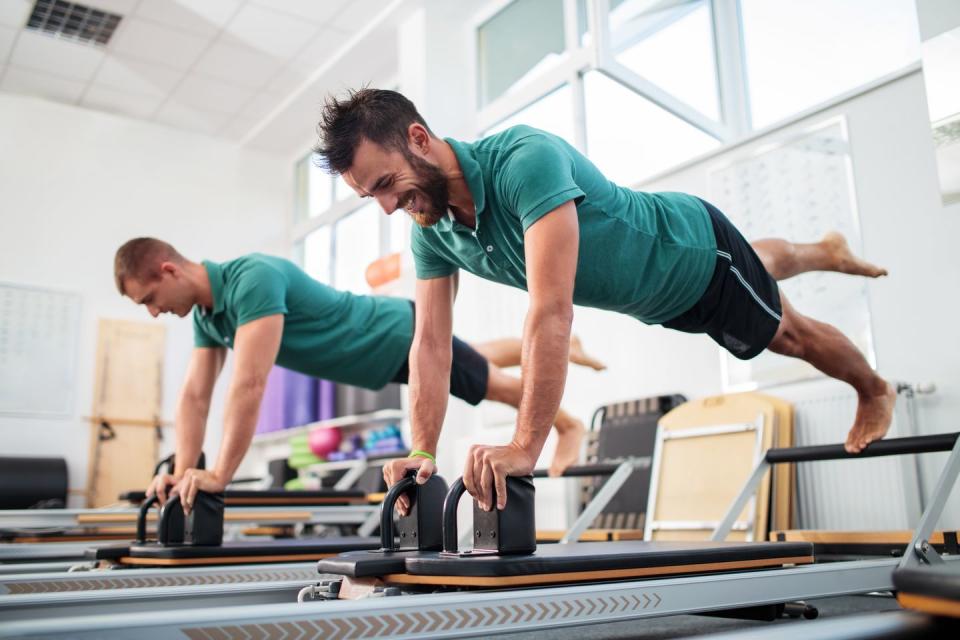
[334,202,383,293]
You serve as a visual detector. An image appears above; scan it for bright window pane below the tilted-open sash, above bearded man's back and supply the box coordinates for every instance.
[583,71,719,186]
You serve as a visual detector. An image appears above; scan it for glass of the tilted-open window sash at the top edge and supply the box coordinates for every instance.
[610,0,720,120]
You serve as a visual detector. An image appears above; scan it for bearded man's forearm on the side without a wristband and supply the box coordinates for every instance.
[513,304,573,458]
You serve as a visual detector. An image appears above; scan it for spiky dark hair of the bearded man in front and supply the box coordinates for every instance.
[313,88,433,174]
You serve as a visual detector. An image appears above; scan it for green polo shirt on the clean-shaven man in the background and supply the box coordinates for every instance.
[193,253,413,389]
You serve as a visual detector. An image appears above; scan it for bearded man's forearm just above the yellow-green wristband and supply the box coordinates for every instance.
[410,340,453,455]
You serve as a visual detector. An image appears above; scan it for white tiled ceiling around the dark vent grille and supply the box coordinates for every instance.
[0,0,397,142]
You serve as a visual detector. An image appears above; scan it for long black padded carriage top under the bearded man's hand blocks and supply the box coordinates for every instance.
[405,541,813,577]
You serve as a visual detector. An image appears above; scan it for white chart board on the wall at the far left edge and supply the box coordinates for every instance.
[0,282,80,415]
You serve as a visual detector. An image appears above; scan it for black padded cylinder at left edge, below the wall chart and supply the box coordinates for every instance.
[0,457,67,509]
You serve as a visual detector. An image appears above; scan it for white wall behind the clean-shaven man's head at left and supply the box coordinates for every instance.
[0,94,293,502]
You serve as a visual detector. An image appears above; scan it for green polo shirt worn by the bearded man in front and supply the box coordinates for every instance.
[411,126,716,324]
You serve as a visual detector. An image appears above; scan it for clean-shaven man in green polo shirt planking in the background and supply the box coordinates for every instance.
[114,238,598,510]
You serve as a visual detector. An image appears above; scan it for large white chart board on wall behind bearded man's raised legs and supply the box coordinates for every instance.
[709,116,874,391]
